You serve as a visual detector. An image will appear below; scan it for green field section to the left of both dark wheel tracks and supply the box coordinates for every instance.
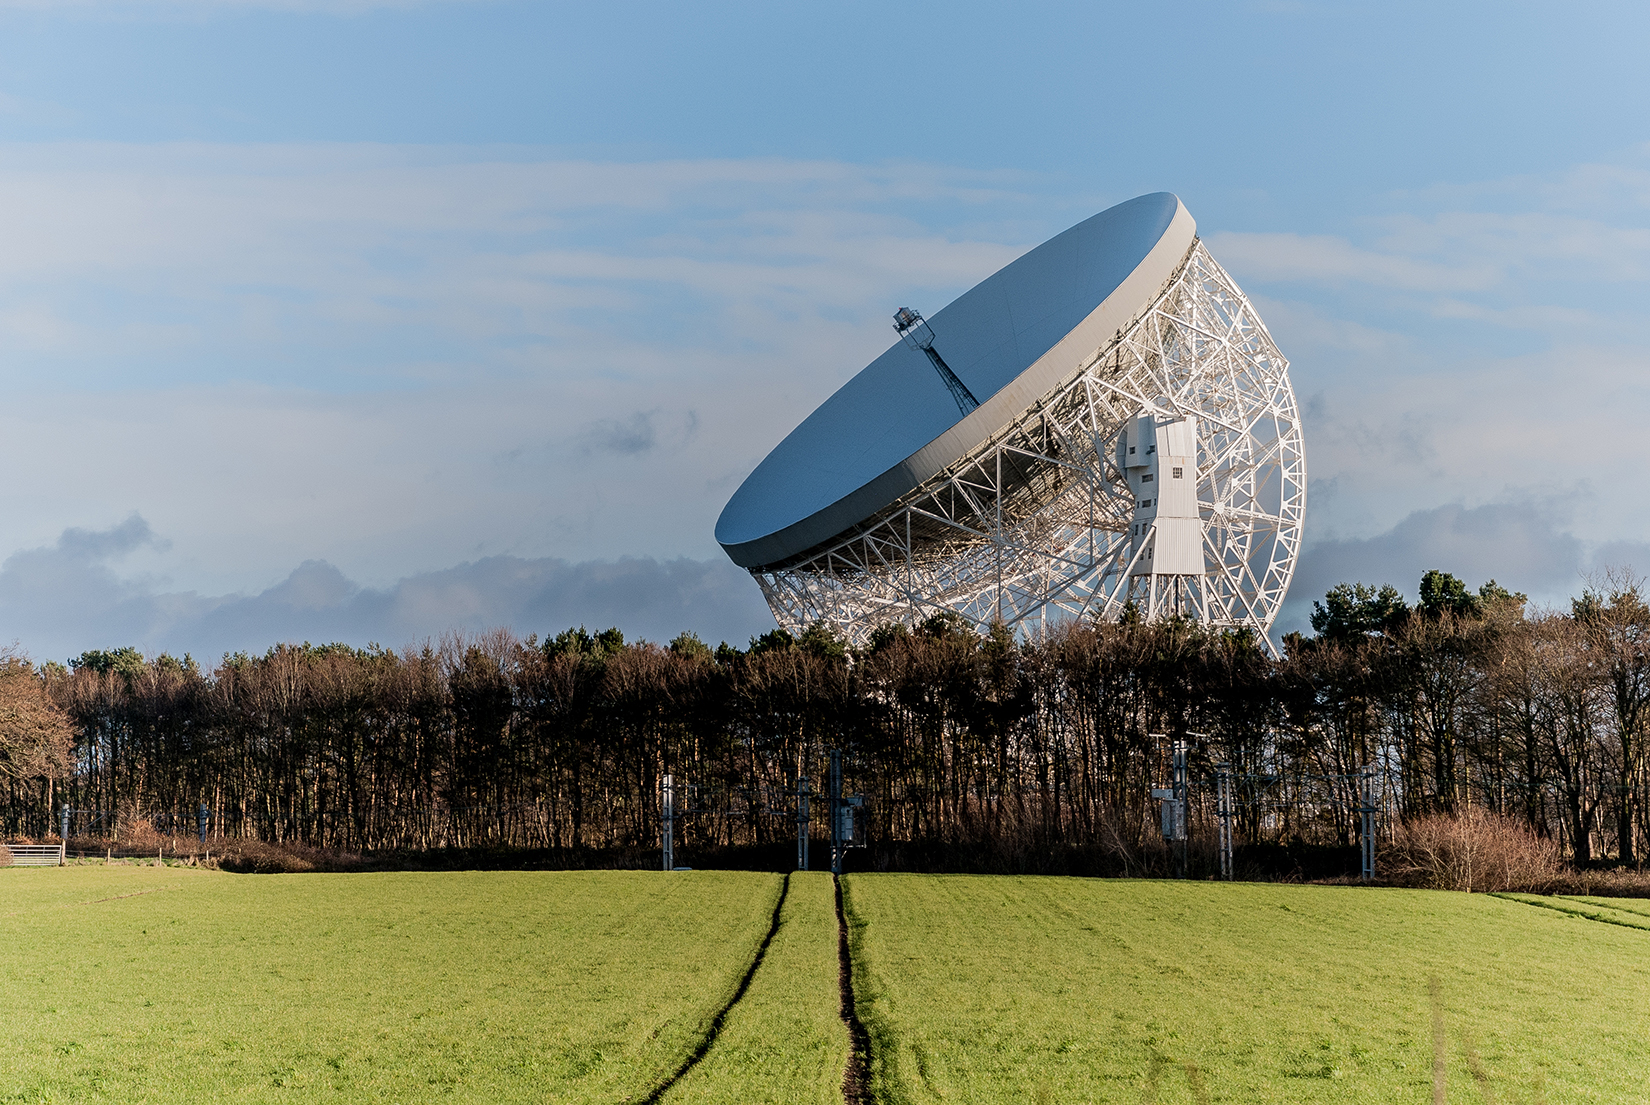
[0,868,779,1102]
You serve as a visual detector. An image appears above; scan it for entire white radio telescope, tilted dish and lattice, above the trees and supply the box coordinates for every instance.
[716,193,1307,643]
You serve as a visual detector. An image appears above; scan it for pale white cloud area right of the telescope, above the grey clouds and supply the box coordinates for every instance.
[1211,150,1650,580]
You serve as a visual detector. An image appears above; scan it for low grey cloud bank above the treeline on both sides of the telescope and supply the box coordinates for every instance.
[0,501,1650,660]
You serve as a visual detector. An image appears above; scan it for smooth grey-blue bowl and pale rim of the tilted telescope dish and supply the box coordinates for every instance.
[716,191,1196,569]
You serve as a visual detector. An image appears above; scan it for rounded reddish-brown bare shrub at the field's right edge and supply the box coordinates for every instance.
[1381,808,1563,894]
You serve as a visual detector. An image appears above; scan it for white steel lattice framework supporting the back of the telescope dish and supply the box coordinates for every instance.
[752,241,1307,643]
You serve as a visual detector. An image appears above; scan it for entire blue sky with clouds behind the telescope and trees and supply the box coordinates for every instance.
[0,0,1650,656]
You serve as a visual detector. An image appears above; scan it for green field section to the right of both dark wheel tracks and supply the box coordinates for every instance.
[846,874,1650,1105]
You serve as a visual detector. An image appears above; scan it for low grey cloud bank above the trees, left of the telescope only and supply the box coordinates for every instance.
[0,515,774,660]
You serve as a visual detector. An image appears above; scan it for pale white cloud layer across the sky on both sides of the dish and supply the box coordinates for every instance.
[0,145,1650,643]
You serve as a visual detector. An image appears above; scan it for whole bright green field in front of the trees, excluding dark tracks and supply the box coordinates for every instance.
[0,866,1650,1105]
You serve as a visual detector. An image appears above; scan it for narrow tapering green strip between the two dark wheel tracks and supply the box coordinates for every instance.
[663,871,848,1105]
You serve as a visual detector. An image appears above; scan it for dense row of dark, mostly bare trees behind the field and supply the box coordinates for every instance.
[0,572,1650,864]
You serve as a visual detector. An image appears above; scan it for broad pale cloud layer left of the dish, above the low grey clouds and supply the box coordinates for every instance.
[0,143,1069,620]
